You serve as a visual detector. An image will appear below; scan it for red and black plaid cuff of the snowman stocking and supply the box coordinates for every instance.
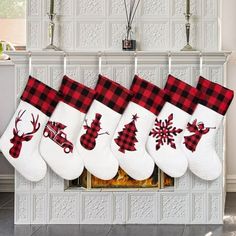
[95,75,132,114]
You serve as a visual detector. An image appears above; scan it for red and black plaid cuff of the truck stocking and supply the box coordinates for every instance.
[59,75,96,113]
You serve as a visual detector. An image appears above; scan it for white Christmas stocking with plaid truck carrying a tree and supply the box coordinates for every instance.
[40,76,95,180]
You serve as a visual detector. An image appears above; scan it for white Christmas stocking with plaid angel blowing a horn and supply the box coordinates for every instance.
[182,77,234,180]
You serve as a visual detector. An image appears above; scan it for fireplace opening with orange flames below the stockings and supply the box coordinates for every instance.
[66,167,174,190]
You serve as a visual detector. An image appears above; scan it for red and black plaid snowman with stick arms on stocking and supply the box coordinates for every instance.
[80,113,109,150]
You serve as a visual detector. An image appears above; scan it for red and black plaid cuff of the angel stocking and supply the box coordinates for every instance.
[197,77,234,115]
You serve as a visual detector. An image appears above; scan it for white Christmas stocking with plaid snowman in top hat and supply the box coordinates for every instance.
[77,75,131,180]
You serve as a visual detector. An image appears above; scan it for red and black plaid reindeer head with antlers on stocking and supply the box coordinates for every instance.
[9,110,40,158]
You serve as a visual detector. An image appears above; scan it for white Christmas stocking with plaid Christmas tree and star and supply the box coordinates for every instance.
[111,76,164,180]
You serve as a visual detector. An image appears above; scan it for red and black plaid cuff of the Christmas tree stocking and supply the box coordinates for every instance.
[130,75,165,115]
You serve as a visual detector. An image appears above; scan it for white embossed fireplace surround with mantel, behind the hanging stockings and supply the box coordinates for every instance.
[9,51,230,224]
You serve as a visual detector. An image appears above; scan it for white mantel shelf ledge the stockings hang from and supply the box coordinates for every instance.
[8,51,231,65]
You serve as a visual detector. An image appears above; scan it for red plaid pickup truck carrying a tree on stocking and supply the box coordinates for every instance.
[43,121,73,153]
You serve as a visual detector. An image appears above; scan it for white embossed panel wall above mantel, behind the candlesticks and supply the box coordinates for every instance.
[27,0,220,51]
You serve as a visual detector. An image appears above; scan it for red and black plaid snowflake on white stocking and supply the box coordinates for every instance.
[149,113,183,150]
